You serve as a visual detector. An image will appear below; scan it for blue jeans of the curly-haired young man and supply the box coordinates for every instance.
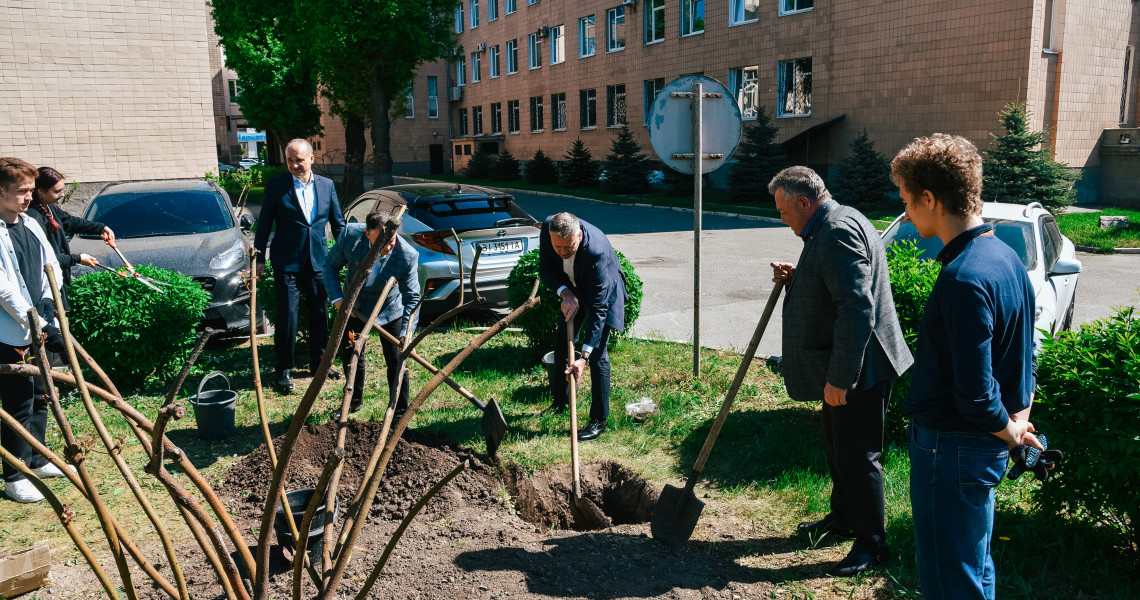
[907,422,1009,600]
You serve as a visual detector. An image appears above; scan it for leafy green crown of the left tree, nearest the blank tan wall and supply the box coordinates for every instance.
[211,0,321,157]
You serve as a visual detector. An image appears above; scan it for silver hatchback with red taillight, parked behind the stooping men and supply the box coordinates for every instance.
[344,183,542,321]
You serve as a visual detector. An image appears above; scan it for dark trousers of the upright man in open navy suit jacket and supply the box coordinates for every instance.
[274,265,328,372]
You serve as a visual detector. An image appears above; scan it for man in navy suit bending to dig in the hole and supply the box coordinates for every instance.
[538,212,626,441]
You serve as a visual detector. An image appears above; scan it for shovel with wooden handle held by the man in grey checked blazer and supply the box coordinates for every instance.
[650,282,783,545]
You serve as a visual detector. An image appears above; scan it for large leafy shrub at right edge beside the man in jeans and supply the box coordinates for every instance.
[1031,306,1140,549]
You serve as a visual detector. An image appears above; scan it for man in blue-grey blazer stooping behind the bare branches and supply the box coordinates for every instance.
[324,212,420,419]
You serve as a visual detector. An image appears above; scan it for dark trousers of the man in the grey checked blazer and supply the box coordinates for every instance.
[823,378,895,551]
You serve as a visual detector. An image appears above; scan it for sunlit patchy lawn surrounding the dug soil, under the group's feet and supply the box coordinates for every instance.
[0,327,1140,600]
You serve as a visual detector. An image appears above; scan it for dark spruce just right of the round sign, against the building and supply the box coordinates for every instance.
[728,105,788,202]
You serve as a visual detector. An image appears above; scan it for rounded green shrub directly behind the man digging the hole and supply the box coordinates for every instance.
[506,249,642,352]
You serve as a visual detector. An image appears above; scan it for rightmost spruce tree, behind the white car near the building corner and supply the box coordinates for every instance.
[982,103,1081,210]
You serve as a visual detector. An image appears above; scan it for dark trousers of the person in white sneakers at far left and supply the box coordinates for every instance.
[0,342,48,481]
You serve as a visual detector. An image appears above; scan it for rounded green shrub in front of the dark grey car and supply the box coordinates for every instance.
[68,265,210,390]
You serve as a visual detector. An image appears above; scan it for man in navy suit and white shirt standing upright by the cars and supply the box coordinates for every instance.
[253,139,344,394]
